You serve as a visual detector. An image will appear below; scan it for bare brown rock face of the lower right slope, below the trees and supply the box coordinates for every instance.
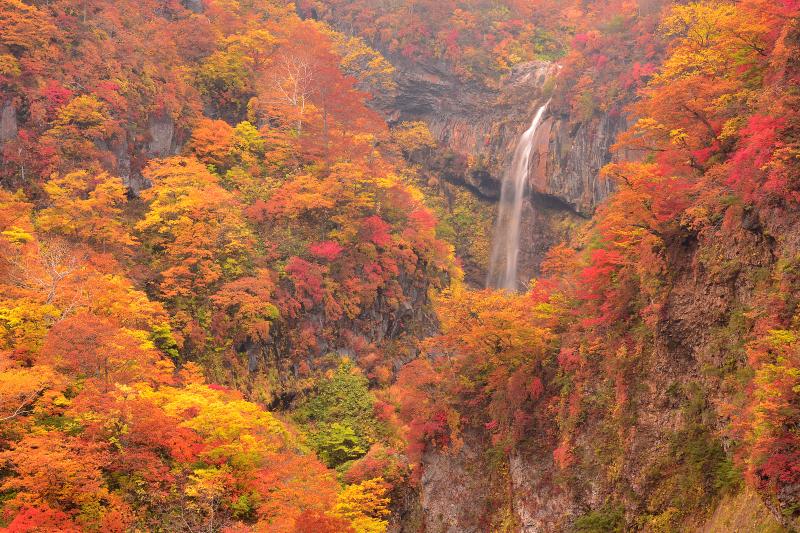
[412,205,800,533]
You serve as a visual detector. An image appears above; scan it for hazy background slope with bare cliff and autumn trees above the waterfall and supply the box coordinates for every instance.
[299,0,666,284]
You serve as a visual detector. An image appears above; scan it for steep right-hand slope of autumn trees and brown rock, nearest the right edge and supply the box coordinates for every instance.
[390,1,800,532]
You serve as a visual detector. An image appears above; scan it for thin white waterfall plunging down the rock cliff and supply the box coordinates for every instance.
[486,100,550,291]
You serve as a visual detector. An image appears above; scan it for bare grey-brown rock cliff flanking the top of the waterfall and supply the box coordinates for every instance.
[376,58,626,279]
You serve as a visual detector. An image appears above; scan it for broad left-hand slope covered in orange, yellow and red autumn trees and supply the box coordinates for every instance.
[0,0,461,533]
